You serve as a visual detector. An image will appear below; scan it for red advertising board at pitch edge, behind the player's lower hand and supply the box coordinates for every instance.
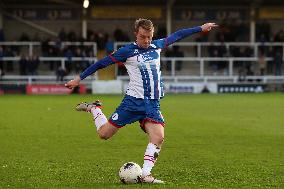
[26,85,86,94]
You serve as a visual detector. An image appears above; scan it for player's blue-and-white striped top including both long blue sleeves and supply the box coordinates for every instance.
[80,27,201,99]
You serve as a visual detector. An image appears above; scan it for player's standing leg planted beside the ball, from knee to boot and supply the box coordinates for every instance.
[142,121,164,184]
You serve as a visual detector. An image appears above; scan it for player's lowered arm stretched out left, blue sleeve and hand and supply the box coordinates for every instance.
[65,48,125,89]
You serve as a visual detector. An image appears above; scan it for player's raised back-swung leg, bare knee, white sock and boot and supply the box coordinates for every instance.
[76,100,119,140]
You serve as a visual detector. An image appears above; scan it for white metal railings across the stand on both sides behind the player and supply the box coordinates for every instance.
[0,42,284,83]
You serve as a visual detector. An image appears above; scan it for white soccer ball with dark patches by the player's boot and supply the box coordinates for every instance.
[118,162,142,184]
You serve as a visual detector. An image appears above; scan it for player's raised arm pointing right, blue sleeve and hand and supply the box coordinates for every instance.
[155,23,218,48]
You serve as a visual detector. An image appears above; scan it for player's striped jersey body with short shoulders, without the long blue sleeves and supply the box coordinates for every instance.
[110,40,165,99]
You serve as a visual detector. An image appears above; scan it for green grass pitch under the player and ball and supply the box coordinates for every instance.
[0,93,284,189]
